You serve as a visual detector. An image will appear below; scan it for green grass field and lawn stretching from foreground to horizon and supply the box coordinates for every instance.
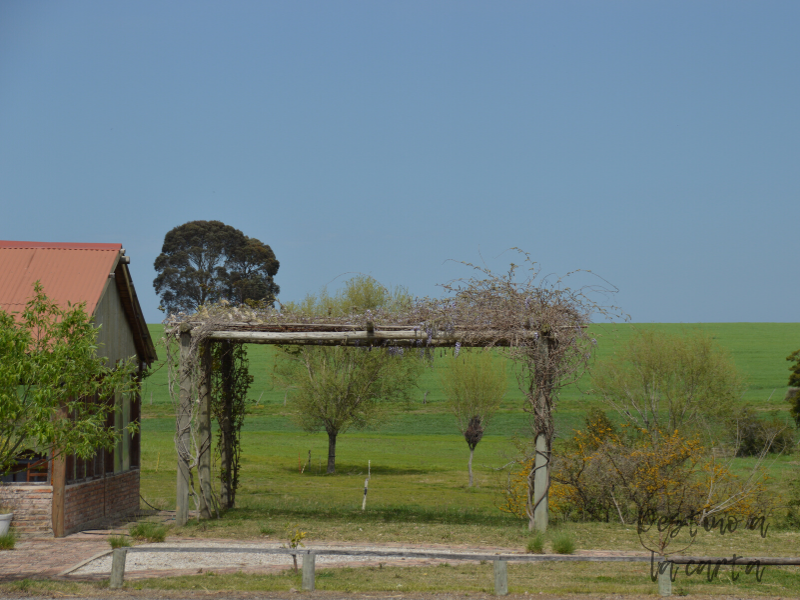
[126,323,800,595]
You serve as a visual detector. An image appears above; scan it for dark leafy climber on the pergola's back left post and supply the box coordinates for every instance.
[211,342,253,508]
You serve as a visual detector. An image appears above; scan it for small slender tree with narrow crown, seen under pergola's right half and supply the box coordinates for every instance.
[441,351,507,487]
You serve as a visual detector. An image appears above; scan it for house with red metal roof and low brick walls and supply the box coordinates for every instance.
[0,241,156,537]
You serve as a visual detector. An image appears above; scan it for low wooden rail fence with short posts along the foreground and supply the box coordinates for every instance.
[109,546,800,596]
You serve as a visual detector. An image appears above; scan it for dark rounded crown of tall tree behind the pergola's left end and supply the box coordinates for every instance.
[153,221,280,314]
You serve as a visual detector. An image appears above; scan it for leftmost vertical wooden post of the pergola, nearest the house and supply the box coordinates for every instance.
[175,331,192,527]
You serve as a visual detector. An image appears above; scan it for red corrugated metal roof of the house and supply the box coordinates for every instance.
[0,240,122,315]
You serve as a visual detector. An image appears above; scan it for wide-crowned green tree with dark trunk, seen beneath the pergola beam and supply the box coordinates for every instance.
[275,347,420,474]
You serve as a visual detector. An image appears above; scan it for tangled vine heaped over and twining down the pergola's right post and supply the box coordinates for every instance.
[434,250,622,531]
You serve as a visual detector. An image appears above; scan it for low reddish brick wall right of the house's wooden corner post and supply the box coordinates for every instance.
[64,469,139,535]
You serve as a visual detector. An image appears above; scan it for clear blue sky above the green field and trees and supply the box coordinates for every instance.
[0,0,800,322]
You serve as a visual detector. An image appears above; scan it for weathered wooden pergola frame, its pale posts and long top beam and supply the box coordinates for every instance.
[175,321,550,527]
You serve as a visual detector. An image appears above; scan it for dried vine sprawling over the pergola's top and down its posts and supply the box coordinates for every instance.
[165,253,623,529]
